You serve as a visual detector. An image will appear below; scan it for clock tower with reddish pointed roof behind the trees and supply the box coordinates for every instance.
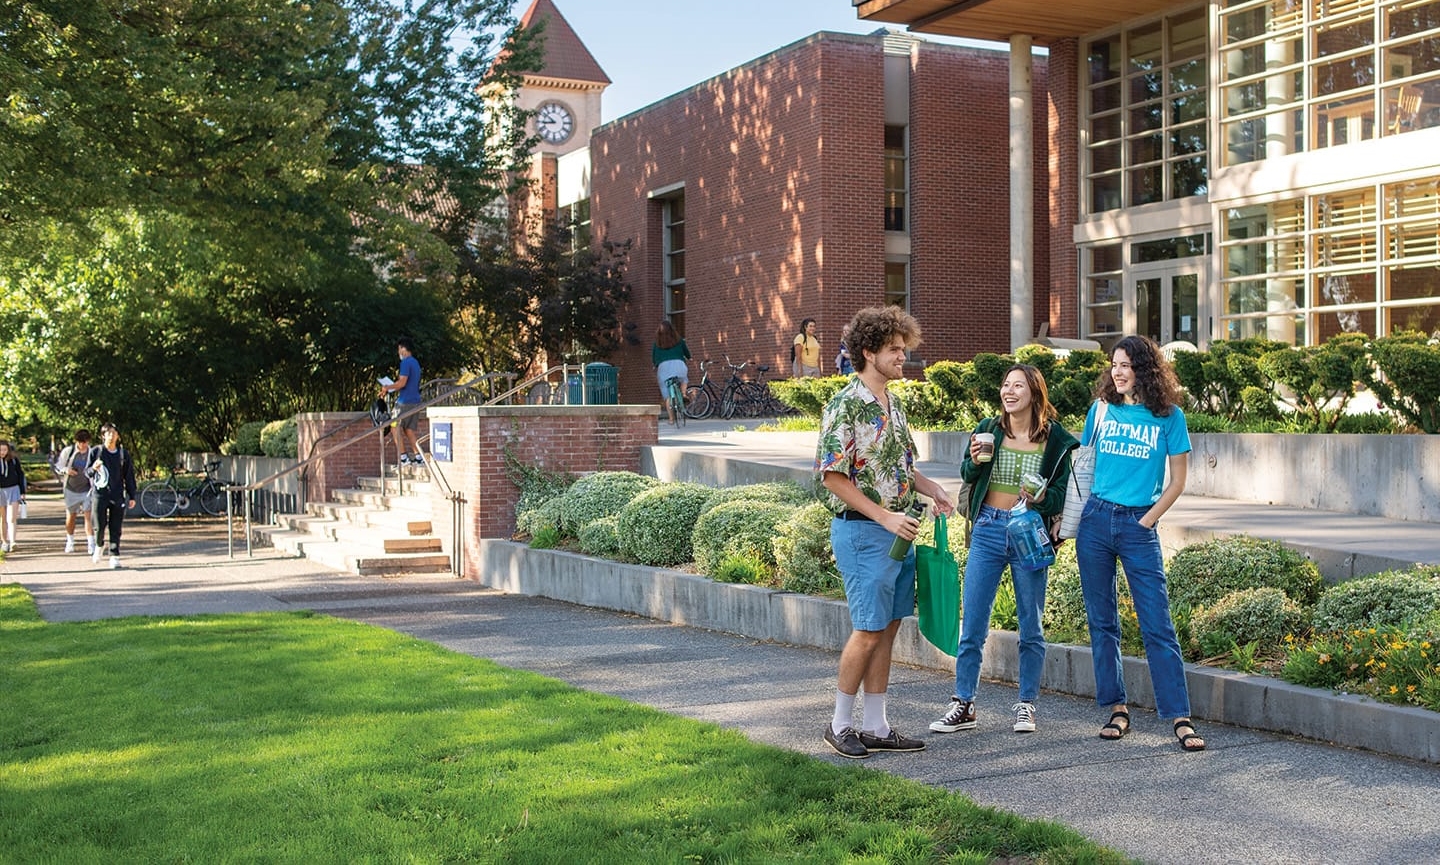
[516,0,611,217]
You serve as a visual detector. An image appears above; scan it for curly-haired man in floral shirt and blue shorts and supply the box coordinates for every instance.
[815,307,955,760]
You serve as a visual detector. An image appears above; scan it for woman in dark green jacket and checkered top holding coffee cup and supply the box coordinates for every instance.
[930,364,1079,733]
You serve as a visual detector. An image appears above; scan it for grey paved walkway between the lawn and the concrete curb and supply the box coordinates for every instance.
[8,495,1440,864]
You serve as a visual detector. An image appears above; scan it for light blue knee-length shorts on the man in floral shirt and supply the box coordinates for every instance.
[829,517,914,630]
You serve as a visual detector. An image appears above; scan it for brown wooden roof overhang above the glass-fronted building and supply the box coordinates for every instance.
[851,0,1184,45]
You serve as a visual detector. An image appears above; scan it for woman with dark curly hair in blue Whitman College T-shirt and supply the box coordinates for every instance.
[1076,335,1205,751]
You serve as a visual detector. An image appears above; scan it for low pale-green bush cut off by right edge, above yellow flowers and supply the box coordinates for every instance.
[1310,566,1440,633]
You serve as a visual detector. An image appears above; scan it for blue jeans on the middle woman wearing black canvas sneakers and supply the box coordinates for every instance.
[955,505,1050,702]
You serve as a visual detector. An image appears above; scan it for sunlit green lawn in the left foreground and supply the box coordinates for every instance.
[0,586,1125,864]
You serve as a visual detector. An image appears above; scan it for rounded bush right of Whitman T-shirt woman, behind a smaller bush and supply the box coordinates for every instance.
[1166,535,1323,607]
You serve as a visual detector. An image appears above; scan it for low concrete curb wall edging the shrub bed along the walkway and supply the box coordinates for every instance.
[478,538,1440,763]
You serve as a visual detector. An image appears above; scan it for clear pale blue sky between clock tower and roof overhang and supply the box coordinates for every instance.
[538,0,990,122]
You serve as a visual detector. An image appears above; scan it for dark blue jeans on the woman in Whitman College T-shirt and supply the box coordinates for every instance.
[1076,495,1189,718]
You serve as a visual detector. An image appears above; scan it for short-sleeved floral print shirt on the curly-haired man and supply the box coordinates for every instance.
[815,377,914,514]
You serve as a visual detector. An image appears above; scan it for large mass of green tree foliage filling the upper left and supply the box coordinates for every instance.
[0,0,624,457]
